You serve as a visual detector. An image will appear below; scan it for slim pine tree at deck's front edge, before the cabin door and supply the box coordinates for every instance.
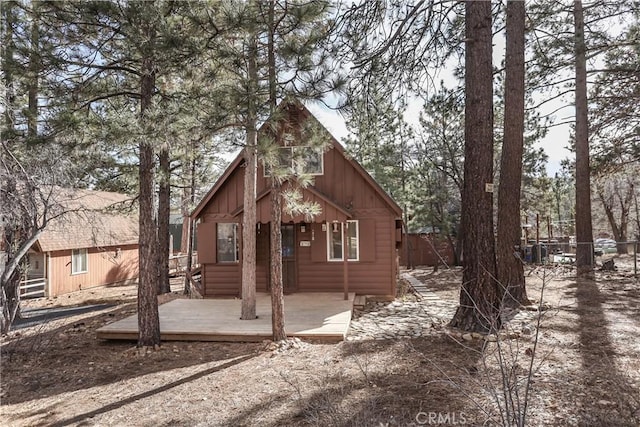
[262,1,338,341]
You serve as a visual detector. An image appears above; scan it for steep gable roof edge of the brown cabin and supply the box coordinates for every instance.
[191,99,402,219]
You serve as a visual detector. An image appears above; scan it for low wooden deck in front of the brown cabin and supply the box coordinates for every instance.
[97,293,355,342]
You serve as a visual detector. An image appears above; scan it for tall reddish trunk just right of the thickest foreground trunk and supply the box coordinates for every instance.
[496,0,529,306]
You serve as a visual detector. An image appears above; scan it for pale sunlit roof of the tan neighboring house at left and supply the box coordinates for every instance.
[36,189,138,252]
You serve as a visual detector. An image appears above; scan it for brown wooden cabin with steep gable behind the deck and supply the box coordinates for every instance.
[192,101,402,297]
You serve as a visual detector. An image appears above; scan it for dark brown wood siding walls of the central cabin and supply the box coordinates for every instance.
[194,103,401,297]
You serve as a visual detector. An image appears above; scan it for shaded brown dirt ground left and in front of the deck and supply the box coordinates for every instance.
[0,304,262,404]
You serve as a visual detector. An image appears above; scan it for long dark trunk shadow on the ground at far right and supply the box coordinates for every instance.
[575,279,640,426]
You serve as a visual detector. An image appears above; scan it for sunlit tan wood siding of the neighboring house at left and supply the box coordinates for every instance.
[45,245,138,296]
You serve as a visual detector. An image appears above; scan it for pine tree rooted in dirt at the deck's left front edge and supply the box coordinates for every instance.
[47,1,211,346]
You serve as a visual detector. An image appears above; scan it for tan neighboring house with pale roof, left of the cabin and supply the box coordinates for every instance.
[27,189,138,297]
